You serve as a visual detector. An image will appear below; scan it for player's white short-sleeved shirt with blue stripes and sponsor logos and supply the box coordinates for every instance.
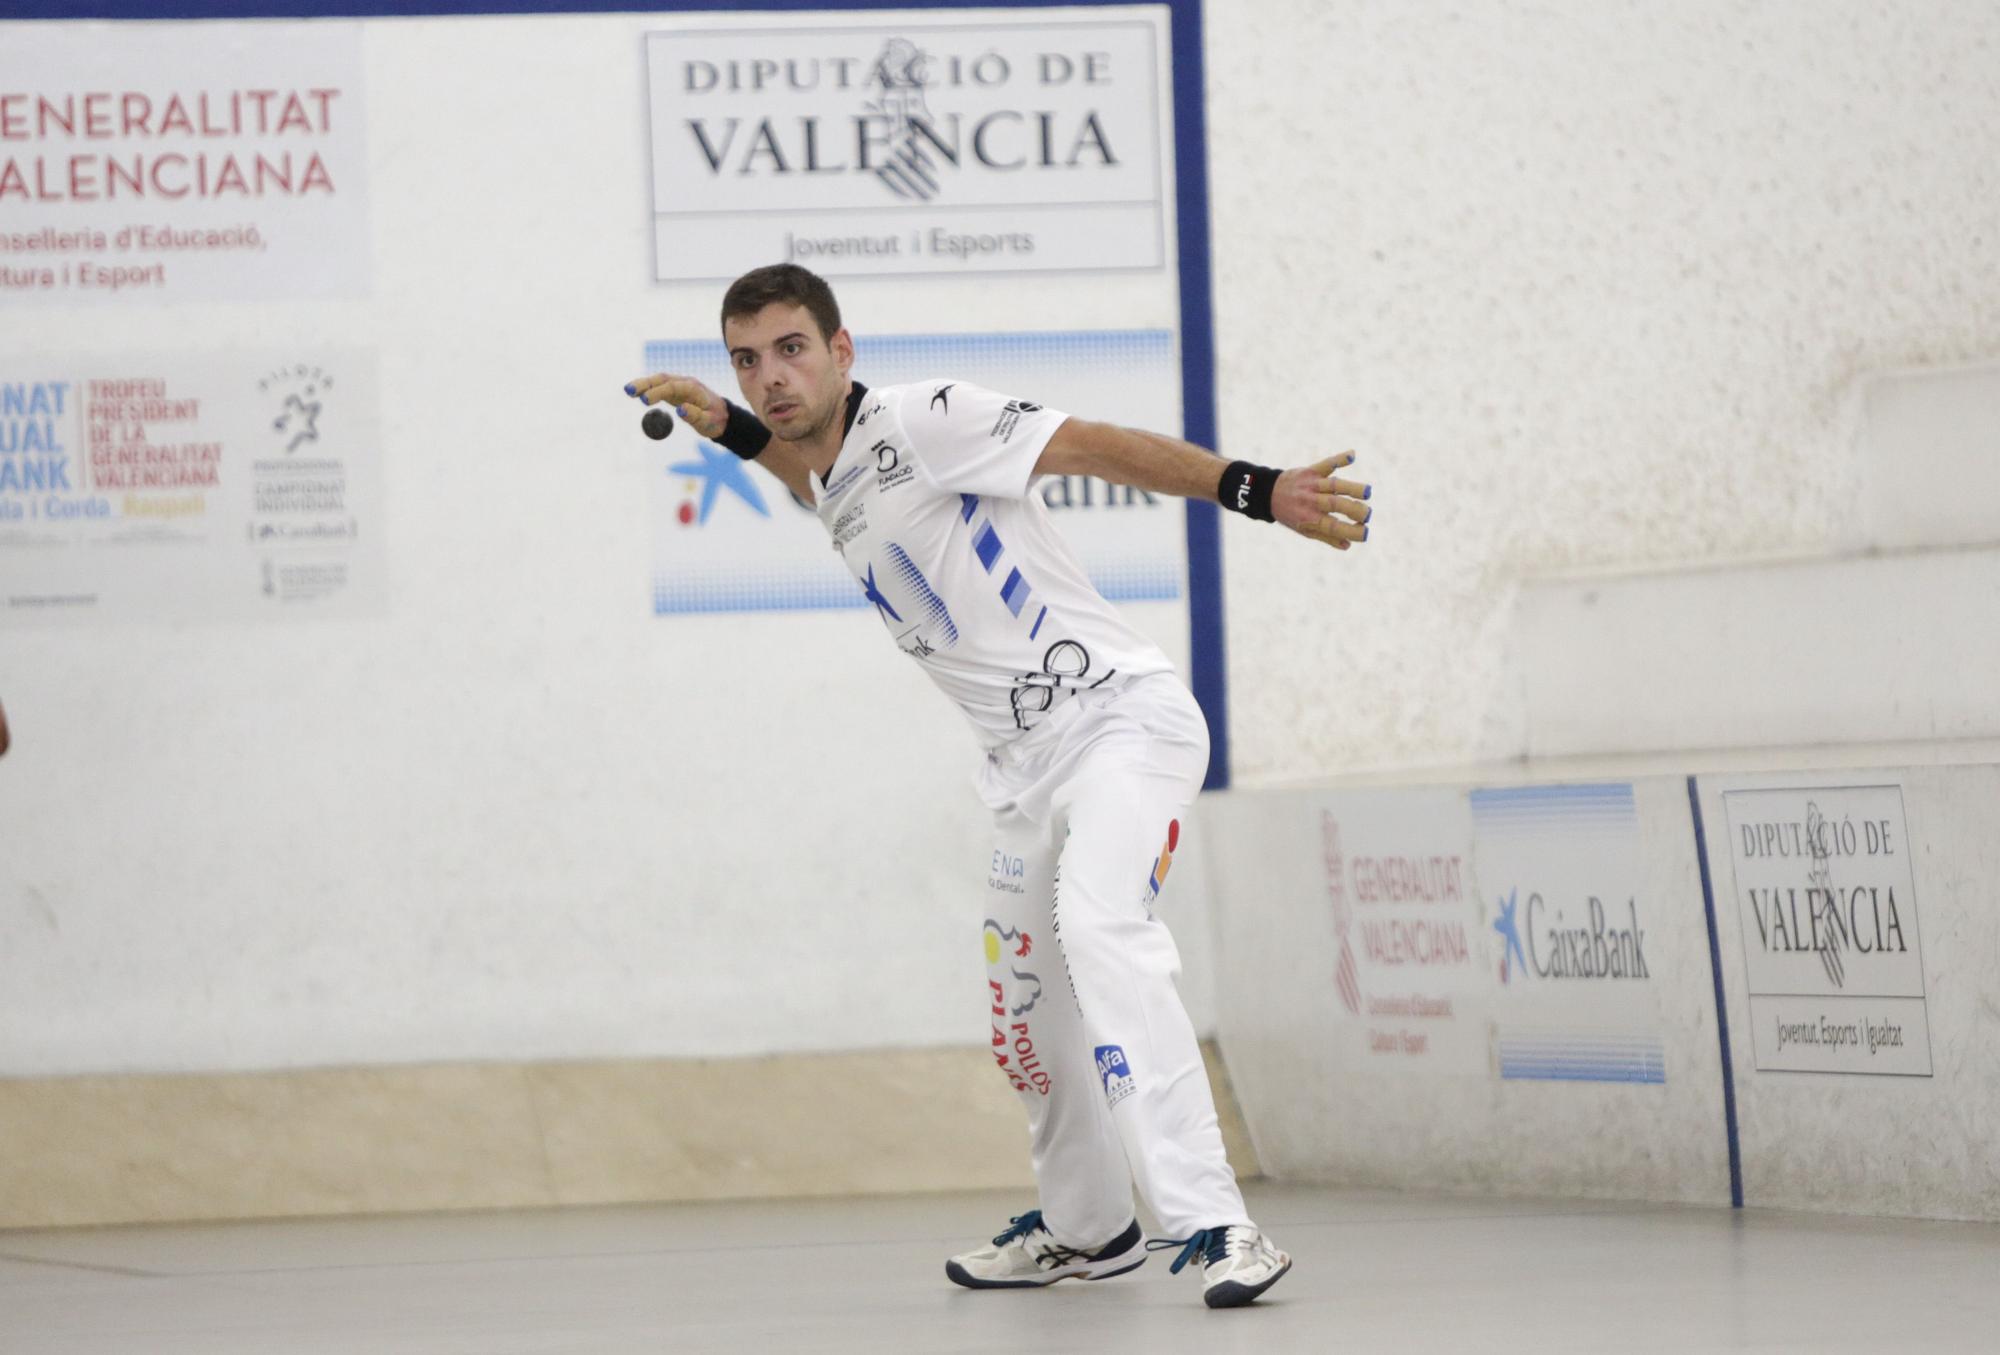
[810,378,1172,747]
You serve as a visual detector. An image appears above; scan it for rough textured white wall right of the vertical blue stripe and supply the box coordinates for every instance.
[1208,0,2000,785]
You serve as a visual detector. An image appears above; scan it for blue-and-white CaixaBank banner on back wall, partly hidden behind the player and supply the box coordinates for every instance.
[634,330,1188,619]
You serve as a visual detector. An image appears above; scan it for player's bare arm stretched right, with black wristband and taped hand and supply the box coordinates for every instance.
[1034,418,1374,550]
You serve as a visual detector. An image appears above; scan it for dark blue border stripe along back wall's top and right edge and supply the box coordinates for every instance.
[0,0,1230,789]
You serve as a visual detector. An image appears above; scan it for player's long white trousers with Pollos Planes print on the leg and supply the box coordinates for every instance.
[980,674,1250,1247]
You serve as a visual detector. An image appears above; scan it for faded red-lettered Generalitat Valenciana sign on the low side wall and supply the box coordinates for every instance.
[1316,789,1492,1077]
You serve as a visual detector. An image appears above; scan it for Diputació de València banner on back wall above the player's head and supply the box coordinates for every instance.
[646,15,1172,282]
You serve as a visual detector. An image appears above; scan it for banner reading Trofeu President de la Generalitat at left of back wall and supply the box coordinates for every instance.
[0,350,384,624]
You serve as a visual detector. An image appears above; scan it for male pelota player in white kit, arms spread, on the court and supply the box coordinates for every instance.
[626,264,1370,1307]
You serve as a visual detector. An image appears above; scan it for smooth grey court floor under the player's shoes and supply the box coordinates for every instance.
[0,1183,2000,1355]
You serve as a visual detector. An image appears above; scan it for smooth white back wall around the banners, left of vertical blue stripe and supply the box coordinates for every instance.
[0,14,1212,1075]
